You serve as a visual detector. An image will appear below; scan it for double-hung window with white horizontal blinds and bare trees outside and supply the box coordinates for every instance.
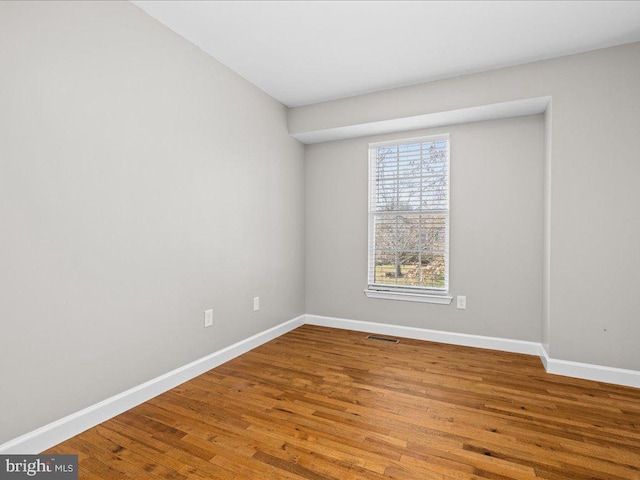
[367,135,451,303]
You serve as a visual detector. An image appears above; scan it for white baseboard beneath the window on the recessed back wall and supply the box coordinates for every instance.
[305,315,540,355]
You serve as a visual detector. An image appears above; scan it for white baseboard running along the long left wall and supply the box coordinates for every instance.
[0,315,304,455]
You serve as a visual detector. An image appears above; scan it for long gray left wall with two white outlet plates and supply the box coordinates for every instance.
[0,2,304,443]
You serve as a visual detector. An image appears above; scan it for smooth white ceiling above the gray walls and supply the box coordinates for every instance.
[133,0,640,106]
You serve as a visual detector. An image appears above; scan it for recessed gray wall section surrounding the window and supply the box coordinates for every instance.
[306,115,544,342]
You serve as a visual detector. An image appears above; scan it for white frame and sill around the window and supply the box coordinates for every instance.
[364,134,453,305]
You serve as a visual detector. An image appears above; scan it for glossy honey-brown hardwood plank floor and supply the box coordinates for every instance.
[46,326,640,480]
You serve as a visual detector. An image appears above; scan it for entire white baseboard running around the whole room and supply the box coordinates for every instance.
[0,315,640,454]
